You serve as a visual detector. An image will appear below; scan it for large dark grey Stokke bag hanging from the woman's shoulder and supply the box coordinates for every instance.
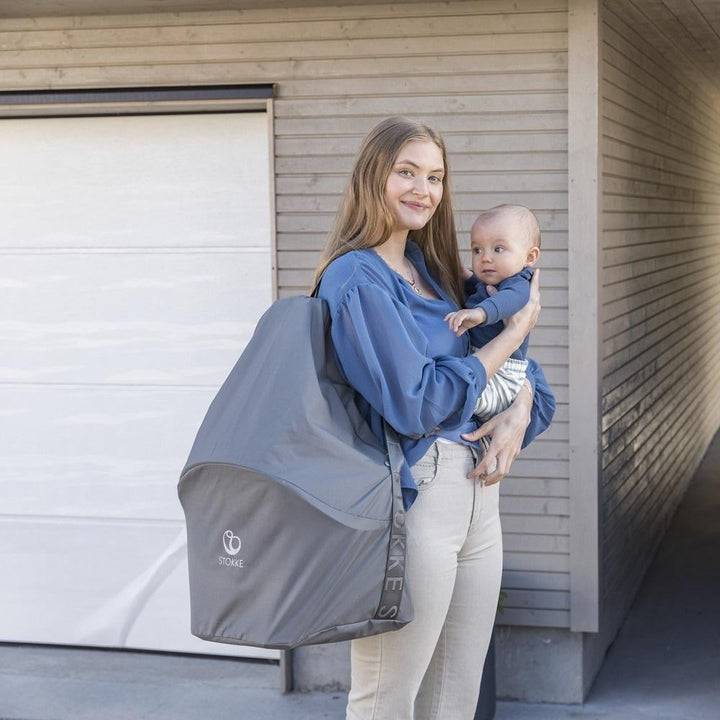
[178,297,412,648]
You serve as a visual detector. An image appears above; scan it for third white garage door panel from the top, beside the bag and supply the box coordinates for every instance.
[0,386,215,520]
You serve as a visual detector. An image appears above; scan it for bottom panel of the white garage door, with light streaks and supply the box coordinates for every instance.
[0,519,277,657]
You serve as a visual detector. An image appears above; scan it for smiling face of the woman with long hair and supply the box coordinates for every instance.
[385,140,445,236]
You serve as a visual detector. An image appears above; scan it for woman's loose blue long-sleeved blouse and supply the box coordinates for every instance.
[318,241,555,508]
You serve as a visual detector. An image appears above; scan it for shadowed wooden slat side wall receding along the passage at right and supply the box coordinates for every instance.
[602,1,720,627]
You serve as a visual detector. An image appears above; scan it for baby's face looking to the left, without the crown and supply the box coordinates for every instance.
[470,215,539,285]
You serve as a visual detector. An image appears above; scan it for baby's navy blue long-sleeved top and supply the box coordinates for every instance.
[465,268,533,360]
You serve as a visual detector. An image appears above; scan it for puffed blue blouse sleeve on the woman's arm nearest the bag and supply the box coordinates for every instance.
[331,284,487,437]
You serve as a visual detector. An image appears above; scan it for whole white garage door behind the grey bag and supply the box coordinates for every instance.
[0,113,277,657]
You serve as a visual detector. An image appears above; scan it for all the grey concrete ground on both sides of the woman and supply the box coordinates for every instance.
[0,436,720,720]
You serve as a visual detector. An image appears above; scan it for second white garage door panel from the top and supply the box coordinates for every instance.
[0,250,271,386]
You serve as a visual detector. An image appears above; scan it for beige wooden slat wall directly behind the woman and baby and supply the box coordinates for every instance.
[0,0,570,627]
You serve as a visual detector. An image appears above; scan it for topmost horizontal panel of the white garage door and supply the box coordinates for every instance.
[0,113,270,248]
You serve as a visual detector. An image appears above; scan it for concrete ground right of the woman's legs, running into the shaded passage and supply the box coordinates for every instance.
[496,433,720,720]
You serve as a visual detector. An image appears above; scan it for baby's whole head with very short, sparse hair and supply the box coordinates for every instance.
[470,205,540,285]
